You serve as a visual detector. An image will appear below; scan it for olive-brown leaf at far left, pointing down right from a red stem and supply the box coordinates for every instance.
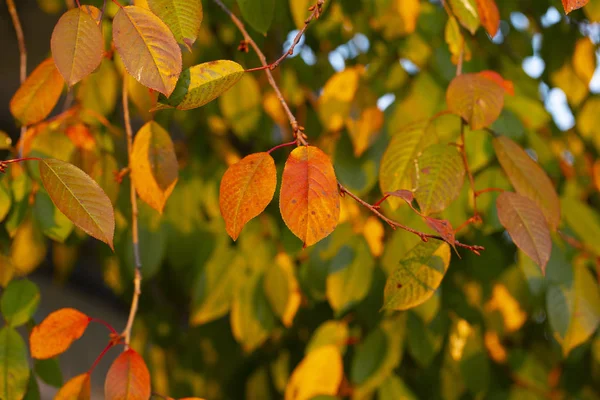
[39,159,115,249]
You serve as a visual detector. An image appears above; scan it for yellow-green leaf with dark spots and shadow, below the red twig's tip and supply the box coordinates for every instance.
[383,240,450,310]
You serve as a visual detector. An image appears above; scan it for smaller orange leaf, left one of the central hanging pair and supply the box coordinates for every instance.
[219,152,277,240]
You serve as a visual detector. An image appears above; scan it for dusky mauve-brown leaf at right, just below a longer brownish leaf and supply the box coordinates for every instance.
[496,192,552,273]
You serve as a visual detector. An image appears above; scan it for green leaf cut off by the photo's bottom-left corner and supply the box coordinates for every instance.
[0,326,29,400]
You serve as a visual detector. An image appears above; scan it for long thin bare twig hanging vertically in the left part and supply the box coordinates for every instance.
[122,83,142,349]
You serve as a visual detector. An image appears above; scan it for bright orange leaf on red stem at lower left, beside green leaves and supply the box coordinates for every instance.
[29,308,90,360]
